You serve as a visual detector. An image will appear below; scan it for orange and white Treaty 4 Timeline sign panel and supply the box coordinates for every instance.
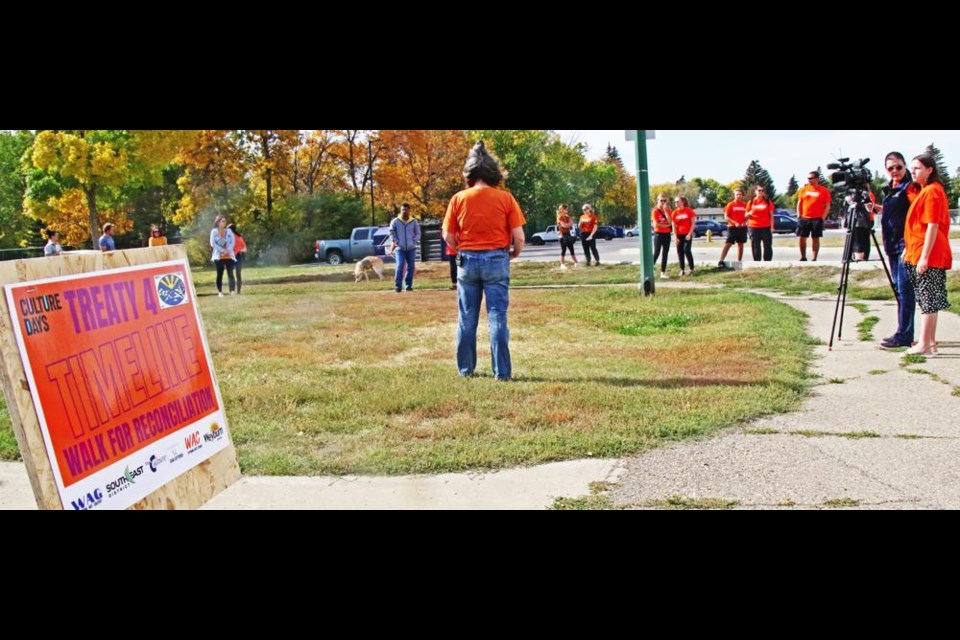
[5,260,230,510]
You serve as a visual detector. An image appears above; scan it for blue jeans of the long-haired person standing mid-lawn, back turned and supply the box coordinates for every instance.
[457,249,513,380]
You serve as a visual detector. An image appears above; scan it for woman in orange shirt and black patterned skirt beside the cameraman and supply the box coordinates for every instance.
[903,154,953,355]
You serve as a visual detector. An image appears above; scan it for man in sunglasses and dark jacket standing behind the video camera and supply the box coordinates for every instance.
[878,151,917,349]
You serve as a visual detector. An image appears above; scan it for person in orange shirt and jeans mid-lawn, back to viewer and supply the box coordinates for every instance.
[443,142,527,380]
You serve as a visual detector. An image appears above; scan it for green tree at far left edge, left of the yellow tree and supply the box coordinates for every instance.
[0,131,39,249]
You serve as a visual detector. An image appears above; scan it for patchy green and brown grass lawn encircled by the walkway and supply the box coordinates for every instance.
[0,263,826,475]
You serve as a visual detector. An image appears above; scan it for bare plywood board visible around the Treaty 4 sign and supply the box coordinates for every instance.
[0,245,240,509]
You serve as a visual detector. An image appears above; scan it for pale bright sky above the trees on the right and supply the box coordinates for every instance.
[556,129,960,192]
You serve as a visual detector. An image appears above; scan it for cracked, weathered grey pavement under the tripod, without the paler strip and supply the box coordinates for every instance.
[611,296,960,509]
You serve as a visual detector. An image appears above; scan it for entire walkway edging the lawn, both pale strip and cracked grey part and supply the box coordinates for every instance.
[0,295,960,509]
